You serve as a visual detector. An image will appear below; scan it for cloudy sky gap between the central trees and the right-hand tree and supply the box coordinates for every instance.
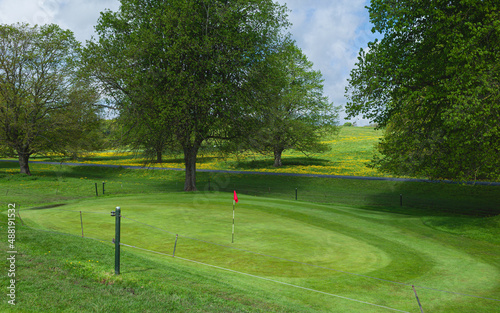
[278,0,374,125]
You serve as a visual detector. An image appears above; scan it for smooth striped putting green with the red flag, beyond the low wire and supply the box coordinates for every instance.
[21,193,500,312]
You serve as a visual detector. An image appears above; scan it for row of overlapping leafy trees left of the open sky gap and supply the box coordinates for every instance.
[0,0,338,191]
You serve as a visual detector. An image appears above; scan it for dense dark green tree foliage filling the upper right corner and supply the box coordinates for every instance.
[347,0,500,180]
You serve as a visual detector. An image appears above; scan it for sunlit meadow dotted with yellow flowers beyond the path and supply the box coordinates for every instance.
[30,127,387,176]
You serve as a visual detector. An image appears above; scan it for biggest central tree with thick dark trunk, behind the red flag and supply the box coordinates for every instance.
[87,0,287,191]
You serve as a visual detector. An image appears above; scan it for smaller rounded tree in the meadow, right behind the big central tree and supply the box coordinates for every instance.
[243,40,338,167]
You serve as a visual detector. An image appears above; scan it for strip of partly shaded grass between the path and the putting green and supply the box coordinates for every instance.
[0,158,500,216]
